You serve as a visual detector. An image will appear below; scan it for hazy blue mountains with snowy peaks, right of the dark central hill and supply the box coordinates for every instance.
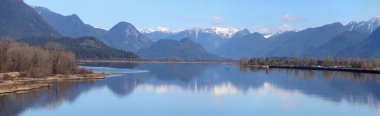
[144,17,380,59]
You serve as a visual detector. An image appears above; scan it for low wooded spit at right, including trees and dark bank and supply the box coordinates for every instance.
[239,57,380,74]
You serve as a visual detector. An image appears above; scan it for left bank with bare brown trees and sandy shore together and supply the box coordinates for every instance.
[0,40,105,94]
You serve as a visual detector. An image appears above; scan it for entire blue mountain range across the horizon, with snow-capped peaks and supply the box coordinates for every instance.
[0,0,380,59]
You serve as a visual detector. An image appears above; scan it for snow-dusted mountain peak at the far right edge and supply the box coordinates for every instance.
[346,16,380,33]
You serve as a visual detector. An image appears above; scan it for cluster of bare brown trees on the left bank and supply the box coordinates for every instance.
[0,39,81,77]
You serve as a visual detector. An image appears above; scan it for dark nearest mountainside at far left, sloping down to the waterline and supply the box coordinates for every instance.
[0,0,138,59]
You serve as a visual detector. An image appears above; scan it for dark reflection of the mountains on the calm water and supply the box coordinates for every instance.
[0,63,380,116]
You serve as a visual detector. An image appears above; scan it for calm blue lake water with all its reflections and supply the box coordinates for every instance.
[0,64,380,116]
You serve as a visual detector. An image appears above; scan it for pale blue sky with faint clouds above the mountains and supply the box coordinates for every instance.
[24,0,380,32]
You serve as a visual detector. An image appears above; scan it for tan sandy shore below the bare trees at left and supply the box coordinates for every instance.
[0,72,108,96]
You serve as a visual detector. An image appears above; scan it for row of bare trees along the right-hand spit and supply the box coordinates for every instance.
[240,57,380,70]
